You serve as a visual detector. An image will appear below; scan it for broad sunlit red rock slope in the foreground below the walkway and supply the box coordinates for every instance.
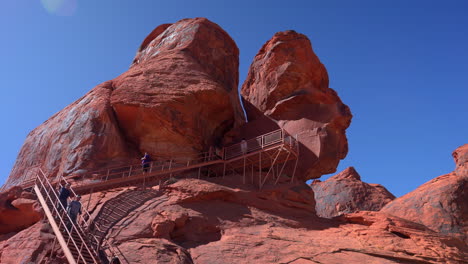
[0,175,468,264]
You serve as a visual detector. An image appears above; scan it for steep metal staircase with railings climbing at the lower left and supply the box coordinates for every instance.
[34,171,100,264]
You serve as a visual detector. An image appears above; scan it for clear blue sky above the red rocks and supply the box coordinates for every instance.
[0,0,468,196]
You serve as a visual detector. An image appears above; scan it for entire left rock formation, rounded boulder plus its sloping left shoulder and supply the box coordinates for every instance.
[6,18,244,190]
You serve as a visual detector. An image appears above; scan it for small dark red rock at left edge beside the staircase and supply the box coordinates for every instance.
[0,187,42,234]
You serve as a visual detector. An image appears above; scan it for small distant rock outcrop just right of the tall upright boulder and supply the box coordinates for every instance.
[311,167,395,218]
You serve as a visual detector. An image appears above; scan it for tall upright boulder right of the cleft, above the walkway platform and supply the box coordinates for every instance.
[241,31,352,179]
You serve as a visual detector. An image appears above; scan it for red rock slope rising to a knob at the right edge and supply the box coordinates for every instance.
[381,145,468,243]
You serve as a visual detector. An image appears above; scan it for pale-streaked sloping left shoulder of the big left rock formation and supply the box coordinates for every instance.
[5,81,137,186]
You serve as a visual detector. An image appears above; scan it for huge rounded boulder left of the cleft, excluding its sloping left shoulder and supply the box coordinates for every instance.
[111,18,244,157]
